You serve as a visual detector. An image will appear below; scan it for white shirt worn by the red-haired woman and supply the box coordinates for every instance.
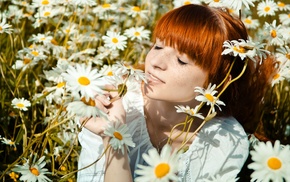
[78,84,249,182]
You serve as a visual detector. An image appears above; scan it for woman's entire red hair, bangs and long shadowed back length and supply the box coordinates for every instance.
[153,4,273,132]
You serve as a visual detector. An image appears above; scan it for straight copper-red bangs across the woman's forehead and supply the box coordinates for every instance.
[153,5,226,70]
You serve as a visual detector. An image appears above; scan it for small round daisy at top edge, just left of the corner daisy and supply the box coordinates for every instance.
[257,0,278,17]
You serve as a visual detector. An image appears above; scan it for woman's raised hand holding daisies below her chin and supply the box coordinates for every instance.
[80,87,126,136]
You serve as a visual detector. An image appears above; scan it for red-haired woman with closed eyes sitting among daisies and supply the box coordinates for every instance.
[78,5,270,182]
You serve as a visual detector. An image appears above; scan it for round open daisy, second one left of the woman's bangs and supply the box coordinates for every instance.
[102,31,127,51]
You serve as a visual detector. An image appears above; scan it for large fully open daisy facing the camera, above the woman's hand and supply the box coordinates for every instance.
[62,64,103,102]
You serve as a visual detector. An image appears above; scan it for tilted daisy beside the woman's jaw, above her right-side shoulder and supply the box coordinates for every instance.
[194,83,225,113]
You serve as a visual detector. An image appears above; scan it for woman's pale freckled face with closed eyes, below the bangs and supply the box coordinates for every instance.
[144,39,207,102]
